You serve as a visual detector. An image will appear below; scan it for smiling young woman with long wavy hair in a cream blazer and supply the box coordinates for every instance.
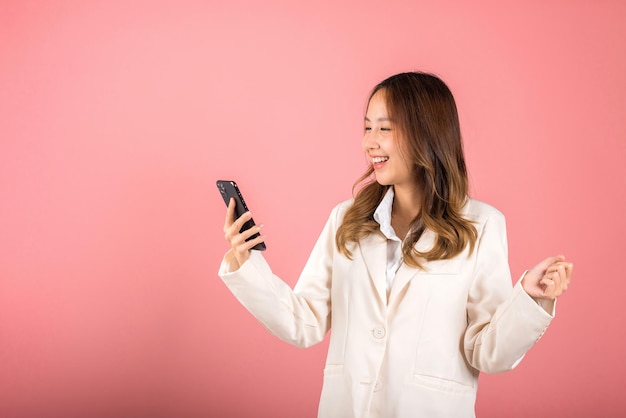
[219,73,573,418]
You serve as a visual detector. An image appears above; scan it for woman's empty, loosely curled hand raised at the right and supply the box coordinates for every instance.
[522,255,574,300]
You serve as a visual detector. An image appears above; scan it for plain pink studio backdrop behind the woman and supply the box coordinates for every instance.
[0,0,626,418]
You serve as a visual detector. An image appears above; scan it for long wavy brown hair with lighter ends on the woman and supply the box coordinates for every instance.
[336,72,477,268]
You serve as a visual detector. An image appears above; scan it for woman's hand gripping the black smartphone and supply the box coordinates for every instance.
[224,198,265,271]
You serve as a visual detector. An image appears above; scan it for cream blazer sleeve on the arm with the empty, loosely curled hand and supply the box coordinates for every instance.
[463,210,552,373]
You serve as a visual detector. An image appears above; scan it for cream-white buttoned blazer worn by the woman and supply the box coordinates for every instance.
[219,200,552,418]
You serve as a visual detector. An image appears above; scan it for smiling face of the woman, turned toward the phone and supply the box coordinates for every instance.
[363,90,415,186]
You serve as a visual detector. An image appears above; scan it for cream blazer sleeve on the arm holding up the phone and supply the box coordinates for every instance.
[218,202,339,348]
